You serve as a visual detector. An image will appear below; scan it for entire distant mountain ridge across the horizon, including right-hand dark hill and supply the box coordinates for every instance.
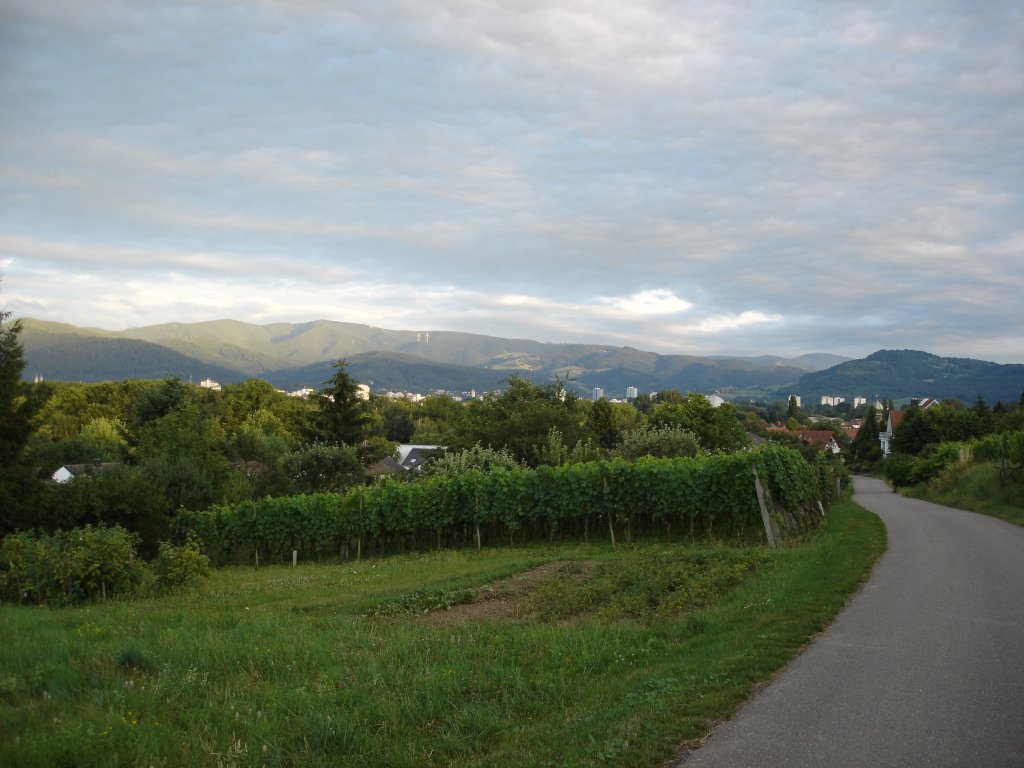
[22,318,1024,402]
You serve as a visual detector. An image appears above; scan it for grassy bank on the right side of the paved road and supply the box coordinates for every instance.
[901,462,1024,525]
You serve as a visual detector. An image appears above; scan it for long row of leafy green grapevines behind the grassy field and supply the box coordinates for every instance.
[175,446,834,560]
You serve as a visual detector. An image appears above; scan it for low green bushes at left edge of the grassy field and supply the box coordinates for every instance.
[0,525,144,605]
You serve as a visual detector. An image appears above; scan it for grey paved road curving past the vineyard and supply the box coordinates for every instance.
[679,478,1024,768]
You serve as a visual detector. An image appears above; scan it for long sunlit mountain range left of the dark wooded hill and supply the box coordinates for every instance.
[22,318,813,395]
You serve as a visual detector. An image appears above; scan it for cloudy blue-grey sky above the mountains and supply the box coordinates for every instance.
[0,0,1024,362]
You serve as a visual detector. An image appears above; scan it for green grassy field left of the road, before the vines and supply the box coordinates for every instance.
[0,502,885,768]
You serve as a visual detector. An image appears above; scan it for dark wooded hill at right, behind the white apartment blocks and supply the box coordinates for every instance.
[797,349,1024,403]
